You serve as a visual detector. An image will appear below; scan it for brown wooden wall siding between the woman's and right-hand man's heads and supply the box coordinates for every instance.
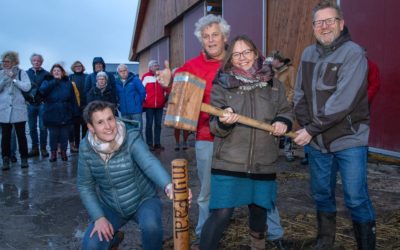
[267,0,319,68]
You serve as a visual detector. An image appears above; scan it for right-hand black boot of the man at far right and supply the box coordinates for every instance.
[353,221,376,250]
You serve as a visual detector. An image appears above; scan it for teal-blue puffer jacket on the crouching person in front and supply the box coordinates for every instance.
[77,122,171,221]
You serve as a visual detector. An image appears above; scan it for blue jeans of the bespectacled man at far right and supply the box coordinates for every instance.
[306,146,375,223]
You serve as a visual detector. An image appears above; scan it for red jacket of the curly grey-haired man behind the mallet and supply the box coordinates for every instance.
[176,51,222,141]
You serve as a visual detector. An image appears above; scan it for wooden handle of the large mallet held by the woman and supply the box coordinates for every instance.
[200,103,297,139]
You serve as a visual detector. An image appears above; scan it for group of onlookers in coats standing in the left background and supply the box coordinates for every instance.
[0,51,169,166]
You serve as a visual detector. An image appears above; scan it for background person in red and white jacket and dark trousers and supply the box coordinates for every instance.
[142,60,165,150]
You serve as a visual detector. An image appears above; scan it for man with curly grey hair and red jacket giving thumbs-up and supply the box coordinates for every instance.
[157,14,230,249]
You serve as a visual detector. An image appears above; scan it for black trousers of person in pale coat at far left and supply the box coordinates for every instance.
[1,122,28,159]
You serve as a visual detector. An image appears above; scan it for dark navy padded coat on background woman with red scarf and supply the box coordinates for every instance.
[39,77,79,127]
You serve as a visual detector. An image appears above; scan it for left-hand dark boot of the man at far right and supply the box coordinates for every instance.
[313,211,336,250]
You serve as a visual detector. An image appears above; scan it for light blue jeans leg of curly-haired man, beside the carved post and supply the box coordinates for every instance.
[195,141,214,239]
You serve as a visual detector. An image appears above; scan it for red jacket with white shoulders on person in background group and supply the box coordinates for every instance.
[142,71,166,108]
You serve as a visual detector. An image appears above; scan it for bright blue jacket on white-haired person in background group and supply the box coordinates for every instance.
[115,74,146,115]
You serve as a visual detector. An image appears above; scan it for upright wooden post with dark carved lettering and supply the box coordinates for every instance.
[171,159,189,250]
